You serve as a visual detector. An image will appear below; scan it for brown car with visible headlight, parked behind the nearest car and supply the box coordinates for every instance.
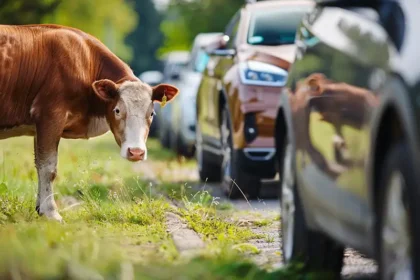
[196,1,313,198]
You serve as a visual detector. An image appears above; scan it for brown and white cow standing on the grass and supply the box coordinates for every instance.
[0,25,178,221]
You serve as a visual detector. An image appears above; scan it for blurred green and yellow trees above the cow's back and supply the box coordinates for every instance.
[0,0,245,72]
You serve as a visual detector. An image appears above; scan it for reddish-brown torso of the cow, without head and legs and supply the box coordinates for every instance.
[0,25,137,138]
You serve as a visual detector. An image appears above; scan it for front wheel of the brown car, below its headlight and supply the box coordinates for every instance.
[220,105,261,199]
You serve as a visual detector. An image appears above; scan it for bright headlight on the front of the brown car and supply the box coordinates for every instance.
[239,61,287,87]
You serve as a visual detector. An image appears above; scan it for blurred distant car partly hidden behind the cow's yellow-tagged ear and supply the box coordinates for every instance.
[156,51,190,148]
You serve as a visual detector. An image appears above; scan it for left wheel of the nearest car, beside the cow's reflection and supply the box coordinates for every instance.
[280,135,344,279]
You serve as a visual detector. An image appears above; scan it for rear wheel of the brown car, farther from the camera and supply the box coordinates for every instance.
[195,125,221,182]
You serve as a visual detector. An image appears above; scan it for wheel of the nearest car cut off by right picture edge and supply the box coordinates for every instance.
[376,142,420,280]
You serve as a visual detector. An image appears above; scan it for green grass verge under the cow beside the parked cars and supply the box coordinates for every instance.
[0,134,334,279]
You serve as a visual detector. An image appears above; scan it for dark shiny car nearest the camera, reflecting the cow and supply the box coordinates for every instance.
[276,1,420,280]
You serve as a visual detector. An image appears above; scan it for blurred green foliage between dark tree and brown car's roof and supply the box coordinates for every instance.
[159,0,245,54]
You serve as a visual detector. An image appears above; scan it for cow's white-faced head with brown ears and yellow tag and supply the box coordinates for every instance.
[92,79,178,161]
